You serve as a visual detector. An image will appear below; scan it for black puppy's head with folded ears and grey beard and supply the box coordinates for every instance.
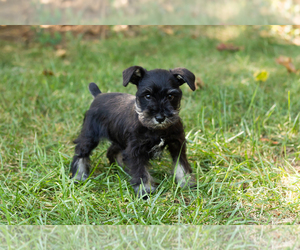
[123,66,195,129]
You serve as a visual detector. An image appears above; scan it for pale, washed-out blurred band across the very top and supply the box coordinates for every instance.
[0,0,300,25]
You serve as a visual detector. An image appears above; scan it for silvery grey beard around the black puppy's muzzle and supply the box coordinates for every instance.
[135,103,179,129]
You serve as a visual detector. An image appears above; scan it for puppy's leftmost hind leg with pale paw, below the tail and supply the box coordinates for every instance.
[71,114,100,181]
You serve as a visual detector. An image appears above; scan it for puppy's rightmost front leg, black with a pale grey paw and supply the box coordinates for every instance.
[168,137,196,187]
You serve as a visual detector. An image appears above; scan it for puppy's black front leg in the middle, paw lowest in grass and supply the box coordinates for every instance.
[123,150,156,198]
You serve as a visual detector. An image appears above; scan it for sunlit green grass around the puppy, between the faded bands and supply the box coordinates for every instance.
[0,26,300,225]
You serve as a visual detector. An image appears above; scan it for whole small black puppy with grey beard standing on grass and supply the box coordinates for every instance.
[71,66,195,196]
